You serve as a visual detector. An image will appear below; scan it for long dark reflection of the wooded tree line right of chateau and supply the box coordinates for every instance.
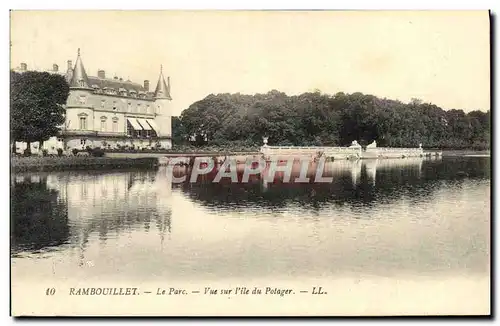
[176,158,490,211]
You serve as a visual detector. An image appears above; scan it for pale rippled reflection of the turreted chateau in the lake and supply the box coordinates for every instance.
[43,169,176,262]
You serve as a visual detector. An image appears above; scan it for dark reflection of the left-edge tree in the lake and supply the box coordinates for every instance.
[10,178,69,253]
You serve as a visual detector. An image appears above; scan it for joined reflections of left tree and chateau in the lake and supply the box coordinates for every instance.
[11,171,172,261]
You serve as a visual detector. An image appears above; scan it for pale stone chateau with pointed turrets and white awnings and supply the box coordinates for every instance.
[16,50,172,154]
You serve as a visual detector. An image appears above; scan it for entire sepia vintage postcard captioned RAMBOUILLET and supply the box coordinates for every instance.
[9,10,491,316]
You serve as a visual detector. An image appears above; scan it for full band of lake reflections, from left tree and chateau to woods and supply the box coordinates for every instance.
[11,158,490,264]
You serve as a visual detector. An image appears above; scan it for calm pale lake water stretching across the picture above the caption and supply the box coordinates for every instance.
[11,157,490,282]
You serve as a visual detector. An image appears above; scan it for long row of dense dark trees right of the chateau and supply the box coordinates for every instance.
[172,90,490,149]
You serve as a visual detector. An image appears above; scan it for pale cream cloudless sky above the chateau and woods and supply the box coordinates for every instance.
[10,11,490,115]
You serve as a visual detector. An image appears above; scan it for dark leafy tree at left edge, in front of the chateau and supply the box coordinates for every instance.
[10,71,69,155]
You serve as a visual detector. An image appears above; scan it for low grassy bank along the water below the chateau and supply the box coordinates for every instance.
[10,156,158,172]
